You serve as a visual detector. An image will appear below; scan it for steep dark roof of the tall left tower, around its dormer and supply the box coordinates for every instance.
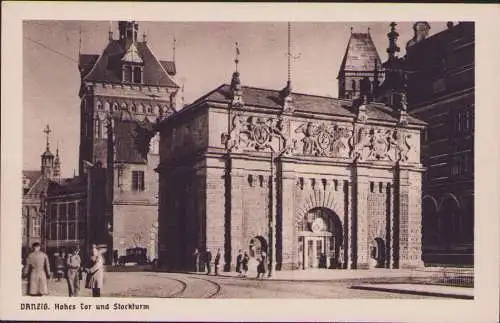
[79,40,179,87]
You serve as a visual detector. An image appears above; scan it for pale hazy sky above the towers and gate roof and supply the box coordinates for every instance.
[23,20,446,177]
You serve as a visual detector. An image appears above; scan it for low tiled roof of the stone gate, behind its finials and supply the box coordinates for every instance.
[189,84,425,124]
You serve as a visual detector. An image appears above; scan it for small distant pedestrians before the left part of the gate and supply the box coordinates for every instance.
[193,249,267,278]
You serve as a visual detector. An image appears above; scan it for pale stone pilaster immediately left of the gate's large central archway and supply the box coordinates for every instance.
[276,172,298,270]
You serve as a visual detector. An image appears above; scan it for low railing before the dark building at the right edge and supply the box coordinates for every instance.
[411,267,474,287]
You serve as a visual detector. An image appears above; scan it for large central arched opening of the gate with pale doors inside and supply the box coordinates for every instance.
[298,207,343,269]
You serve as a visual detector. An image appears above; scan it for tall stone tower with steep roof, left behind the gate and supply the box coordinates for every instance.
[79,21,179,258]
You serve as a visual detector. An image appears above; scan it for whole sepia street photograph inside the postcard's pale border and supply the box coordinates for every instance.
[21,21,474,299]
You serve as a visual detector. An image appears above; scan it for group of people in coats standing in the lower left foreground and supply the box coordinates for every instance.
[23,242,104,297]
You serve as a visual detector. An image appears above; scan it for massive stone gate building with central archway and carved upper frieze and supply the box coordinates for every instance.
[158,72,425,270]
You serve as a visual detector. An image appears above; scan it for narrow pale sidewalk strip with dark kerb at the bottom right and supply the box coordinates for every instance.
[351,284,474,299]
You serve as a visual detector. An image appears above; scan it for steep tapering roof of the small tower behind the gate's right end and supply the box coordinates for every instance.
[339,33,381,74]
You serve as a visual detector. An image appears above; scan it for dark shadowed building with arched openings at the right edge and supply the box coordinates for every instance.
[405,22,475,264]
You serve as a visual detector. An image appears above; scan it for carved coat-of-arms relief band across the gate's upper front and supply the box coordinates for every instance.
[225,115,412,162]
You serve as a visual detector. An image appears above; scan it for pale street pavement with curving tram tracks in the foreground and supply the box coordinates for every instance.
[23,272,437,299]
